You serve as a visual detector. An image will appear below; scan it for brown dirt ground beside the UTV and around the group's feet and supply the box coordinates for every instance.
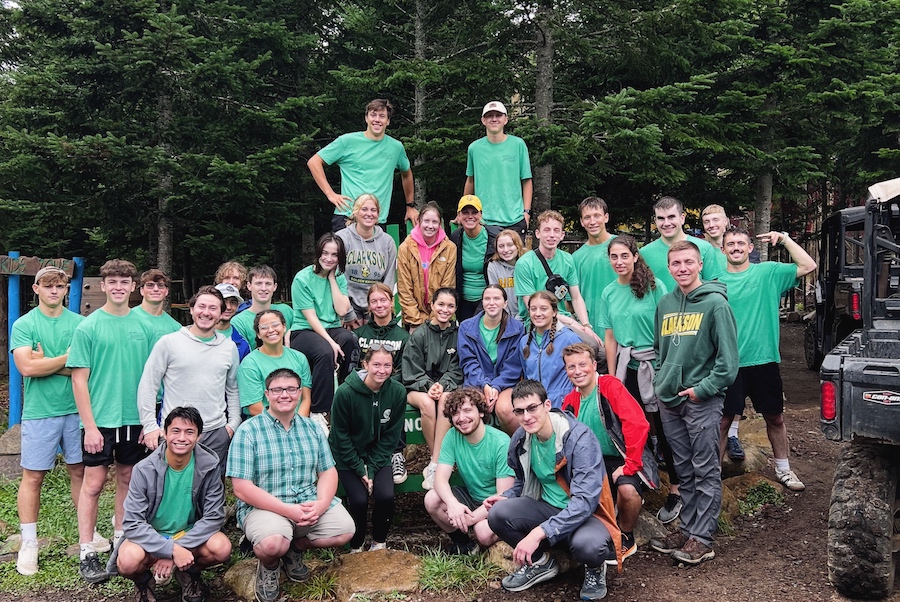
[0,325,900,602]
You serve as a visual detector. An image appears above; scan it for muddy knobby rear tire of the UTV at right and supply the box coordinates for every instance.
[828,443,898,599]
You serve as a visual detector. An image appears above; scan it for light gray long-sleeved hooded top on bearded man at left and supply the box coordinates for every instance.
[138,326,241,433]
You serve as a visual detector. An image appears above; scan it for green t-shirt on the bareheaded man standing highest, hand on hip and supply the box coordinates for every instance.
[316,132,409,224]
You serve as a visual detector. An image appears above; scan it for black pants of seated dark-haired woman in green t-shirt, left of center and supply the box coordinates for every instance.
[291,328,359,412]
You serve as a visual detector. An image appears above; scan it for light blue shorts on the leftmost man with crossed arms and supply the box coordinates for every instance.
[20,414,82,471]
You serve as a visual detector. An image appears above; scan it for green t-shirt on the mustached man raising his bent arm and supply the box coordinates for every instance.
[719,261,797,368]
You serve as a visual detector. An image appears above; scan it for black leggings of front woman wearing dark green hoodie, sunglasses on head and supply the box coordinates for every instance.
[338,466,394,548]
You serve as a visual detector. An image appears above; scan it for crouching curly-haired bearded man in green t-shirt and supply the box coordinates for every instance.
[425,387,514,554]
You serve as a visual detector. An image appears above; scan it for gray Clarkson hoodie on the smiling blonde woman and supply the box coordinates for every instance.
[337,224,397,319]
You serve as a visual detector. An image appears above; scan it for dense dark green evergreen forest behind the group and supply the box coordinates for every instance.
[0,0,900,291]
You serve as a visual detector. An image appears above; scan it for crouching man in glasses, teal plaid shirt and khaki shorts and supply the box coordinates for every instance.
[225,368,356,602]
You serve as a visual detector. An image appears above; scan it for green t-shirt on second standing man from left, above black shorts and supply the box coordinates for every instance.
[66,309,153,428]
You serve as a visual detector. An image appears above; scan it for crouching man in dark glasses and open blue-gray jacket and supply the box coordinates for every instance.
[485,380,621,600]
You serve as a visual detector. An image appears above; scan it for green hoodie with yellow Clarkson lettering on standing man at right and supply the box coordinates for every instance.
[653,282,739,408]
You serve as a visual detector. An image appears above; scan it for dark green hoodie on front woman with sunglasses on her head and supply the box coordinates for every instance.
[328,370,406,479]
